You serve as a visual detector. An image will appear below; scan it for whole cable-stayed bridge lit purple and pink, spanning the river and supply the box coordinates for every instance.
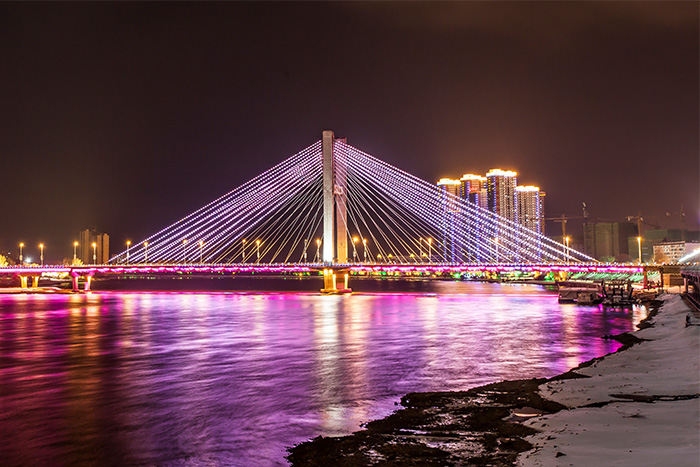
[6,131,652,291]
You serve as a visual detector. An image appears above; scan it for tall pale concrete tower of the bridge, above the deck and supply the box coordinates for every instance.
[322,130,348,263]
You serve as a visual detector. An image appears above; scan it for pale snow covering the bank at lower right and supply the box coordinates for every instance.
[518,295,700,467]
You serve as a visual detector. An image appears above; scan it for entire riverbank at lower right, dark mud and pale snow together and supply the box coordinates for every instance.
[288,295,700,466]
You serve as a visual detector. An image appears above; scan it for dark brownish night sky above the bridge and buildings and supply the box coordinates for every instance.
[0,1,700,260]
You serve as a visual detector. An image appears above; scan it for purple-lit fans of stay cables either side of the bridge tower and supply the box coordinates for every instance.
[111,140,592,264]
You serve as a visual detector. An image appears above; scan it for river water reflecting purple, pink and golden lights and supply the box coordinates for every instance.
[0,282,646,466]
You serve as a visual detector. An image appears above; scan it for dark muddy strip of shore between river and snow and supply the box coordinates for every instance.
[287,301,662,466]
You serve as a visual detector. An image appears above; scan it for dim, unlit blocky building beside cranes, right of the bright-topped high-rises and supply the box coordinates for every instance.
[583,222,637,262]
